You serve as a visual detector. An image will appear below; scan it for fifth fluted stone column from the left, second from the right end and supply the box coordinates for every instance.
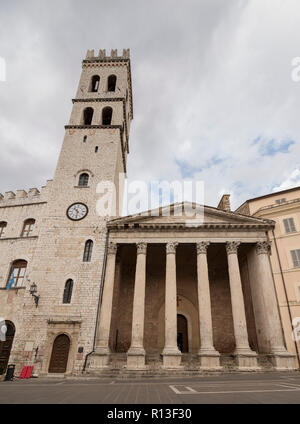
[226,241,257,368]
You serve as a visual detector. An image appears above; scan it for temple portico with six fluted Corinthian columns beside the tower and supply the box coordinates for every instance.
[90,207,293,370]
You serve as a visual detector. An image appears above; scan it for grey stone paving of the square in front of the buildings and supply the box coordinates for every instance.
[0,372,300,405]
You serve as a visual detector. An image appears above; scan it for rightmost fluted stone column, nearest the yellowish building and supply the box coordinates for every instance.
[256,241,295,369]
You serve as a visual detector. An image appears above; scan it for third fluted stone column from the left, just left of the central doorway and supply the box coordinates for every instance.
[163,242,181,368]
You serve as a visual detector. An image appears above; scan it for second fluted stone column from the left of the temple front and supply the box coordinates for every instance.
[127,243,147,369]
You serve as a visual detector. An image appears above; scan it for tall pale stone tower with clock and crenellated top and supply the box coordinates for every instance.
[17,50,133,374]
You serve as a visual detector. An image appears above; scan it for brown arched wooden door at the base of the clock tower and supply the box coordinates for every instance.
[49,334,70,374]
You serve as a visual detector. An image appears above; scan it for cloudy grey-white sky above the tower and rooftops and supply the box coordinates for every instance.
[0,0,300,208]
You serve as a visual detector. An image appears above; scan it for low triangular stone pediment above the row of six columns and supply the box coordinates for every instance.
[108,202,274,227]
